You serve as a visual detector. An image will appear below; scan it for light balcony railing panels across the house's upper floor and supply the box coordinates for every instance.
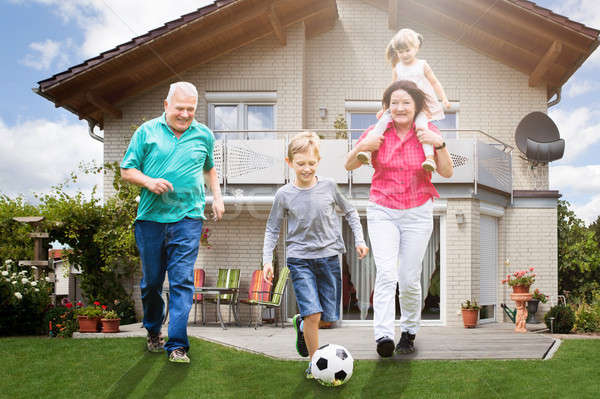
[214,129,514,193]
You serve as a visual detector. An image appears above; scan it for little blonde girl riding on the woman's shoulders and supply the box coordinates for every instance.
[357,29,450,172]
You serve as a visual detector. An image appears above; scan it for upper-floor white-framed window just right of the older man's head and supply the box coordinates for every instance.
[206,92,277,140]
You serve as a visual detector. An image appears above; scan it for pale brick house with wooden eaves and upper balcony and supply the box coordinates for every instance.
[37,0,600,326]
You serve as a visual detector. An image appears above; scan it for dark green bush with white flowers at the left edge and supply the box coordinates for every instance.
[0,262,50,336]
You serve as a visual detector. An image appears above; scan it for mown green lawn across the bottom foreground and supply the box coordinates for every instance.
[0,338,600,399]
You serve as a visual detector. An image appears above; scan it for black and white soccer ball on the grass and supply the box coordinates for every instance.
[310,344,354,386]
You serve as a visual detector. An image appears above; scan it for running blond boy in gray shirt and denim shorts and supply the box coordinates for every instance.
[263,132,369,384]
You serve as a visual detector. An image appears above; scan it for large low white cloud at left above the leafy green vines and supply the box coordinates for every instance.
[0,119,102,199]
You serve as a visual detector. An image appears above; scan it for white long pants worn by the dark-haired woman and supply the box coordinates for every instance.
[367,200,433,340]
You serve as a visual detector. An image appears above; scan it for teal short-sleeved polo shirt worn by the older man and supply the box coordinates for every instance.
[121,113,215,223]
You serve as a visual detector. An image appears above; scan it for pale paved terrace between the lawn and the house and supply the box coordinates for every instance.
[74,323,560,360]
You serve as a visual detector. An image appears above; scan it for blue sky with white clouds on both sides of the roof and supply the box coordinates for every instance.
[0,0,600,223]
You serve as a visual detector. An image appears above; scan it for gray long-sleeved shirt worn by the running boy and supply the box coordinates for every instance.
[263,178,365,264]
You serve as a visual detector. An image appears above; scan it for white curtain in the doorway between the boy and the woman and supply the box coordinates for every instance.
[343,218,376,320]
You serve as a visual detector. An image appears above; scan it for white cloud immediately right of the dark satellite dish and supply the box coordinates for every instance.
[548,107,600,162]
